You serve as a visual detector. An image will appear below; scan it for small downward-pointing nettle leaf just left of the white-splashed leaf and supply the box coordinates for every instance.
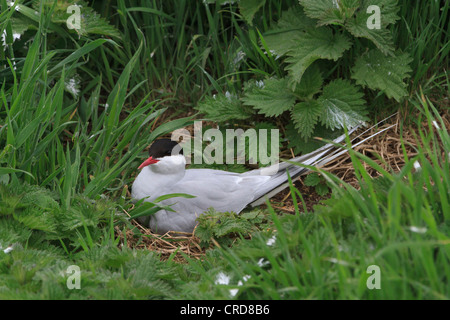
[291,100,323,140]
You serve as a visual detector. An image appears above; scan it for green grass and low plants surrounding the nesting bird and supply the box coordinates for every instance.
[0,0,450,299]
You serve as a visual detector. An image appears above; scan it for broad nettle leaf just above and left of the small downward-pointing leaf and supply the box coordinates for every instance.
[242,78,296,117]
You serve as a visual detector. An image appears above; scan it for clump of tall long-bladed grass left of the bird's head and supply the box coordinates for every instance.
[0,3,190,202]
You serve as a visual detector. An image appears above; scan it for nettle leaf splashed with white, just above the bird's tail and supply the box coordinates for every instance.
[318,79,367,130]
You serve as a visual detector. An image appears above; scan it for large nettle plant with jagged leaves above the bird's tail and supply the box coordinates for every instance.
[195,0,411,152]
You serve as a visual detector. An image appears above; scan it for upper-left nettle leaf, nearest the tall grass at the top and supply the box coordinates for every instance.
[264,6,316,56]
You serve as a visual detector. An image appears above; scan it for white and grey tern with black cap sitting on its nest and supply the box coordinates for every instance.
[131,122,384,234]
